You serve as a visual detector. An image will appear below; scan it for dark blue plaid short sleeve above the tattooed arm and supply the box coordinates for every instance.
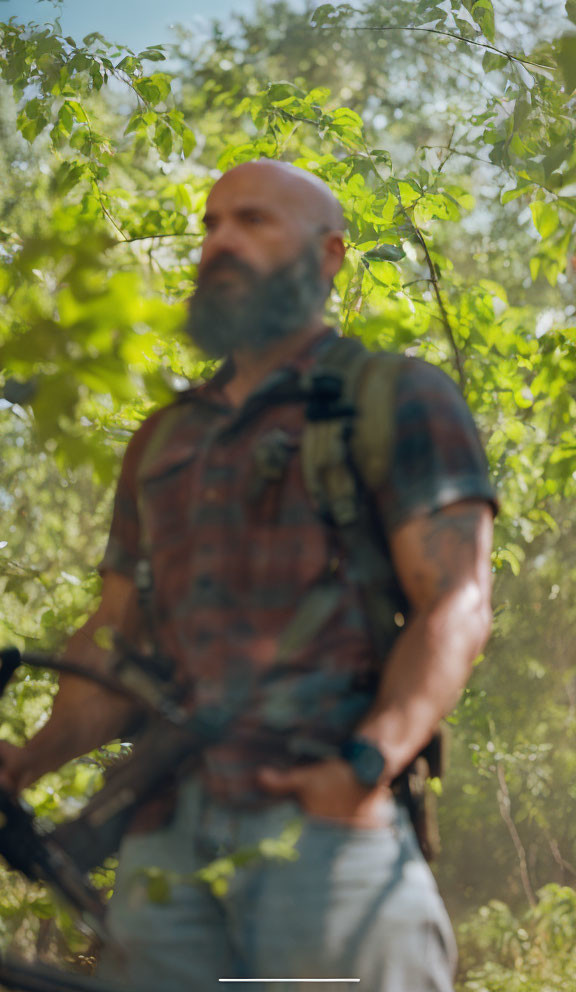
[379,358,497,532]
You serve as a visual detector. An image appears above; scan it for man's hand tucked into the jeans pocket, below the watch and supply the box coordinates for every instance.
[258,758,389,829]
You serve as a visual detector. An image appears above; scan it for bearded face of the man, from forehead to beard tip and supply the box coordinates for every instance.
[187,172,328,357]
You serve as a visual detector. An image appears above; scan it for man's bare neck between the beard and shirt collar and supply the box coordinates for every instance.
[224,317,325,407]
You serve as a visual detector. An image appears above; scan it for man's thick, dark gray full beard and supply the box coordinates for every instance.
[186,245,327,358]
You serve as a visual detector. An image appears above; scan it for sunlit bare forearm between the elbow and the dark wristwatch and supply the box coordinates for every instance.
[358,596,489,780]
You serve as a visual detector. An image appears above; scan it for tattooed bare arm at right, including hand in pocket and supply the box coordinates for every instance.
[261,500,492,826]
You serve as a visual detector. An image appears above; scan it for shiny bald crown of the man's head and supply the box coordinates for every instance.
[213,159,345,232]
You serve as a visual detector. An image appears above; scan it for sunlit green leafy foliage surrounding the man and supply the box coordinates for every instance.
[0,0,576,980]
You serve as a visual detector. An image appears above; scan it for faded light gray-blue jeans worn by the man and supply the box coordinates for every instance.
[99,780,456,992]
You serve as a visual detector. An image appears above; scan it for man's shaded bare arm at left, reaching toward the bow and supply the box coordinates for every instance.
[0,572,136,791]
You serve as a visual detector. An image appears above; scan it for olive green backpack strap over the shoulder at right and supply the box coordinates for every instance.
[277,338,403,660]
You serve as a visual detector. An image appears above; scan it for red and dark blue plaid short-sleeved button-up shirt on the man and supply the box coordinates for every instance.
[101,331,494,804]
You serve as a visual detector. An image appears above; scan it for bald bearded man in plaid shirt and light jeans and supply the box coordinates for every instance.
[0,161,493,992]
